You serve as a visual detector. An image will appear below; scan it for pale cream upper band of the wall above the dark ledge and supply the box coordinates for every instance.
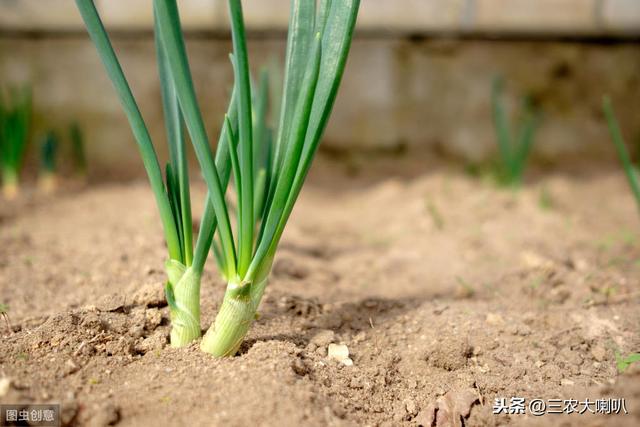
[0,0,640,35]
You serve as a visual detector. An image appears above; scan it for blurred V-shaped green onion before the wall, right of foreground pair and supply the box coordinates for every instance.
[491,77,539,188]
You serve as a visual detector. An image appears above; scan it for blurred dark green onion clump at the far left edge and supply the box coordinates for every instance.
[0,86,31,199]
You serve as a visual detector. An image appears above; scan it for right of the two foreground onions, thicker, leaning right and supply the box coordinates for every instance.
[154,0,359,356]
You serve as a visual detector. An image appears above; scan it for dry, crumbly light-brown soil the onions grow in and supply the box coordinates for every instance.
[0,163,640,426]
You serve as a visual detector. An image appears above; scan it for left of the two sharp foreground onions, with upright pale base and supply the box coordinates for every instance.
[76,0,244,347]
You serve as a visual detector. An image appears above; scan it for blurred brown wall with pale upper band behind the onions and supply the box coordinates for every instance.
[0,0,640,178]
